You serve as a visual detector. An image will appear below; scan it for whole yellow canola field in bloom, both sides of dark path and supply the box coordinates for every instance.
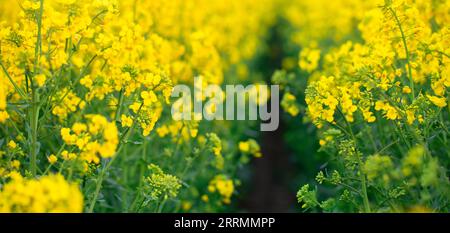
[0,0,450,213]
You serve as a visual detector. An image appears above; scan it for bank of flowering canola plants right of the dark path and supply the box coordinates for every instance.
[286,0,450,212]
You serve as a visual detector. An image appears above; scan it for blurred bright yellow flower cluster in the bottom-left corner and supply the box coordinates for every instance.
[0,175,83,213]
